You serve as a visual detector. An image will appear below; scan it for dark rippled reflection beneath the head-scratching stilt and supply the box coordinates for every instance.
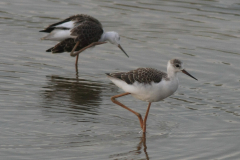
[42,73,104,114]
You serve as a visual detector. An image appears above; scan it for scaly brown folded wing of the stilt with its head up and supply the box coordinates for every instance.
[107,68,167,84]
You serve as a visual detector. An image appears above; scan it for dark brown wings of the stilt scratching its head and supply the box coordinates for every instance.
[42,14,103,53]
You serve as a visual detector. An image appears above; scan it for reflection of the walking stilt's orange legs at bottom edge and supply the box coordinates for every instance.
[109,133,149,160]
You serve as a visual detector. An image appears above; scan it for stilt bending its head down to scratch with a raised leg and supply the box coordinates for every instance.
[39,14,129,66]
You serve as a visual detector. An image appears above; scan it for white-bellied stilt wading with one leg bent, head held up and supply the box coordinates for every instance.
[106,59,197,133]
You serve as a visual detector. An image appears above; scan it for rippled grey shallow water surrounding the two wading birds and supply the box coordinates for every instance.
[0,0,240,160]
